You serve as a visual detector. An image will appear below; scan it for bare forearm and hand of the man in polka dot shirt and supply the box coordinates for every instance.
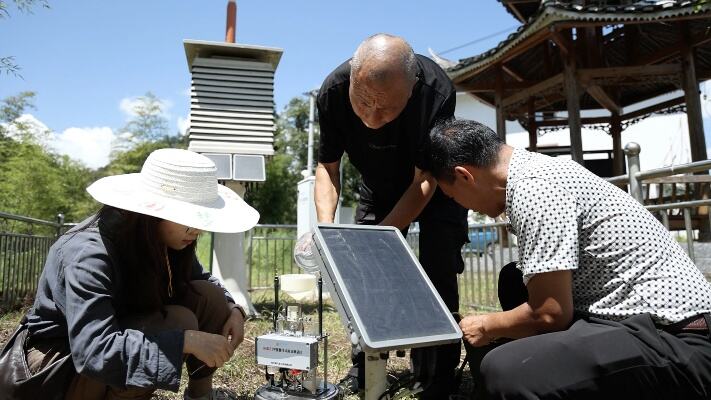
[459,270,573,346]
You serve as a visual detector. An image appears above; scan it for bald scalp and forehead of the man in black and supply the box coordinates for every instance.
[351,33,417,84]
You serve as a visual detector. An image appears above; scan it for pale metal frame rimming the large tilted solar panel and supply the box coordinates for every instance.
[314,224,462,353]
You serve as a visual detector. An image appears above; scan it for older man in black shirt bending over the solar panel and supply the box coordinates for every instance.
[315,34,467,399]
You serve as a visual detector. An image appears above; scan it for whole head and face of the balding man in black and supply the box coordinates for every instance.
[348,33,418,129]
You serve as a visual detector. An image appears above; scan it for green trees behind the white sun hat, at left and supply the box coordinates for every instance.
[0,92,187,222]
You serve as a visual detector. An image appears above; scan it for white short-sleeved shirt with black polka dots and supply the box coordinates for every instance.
[506,149,711,324]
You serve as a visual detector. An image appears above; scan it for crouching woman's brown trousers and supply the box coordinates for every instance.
[26,281,231,400]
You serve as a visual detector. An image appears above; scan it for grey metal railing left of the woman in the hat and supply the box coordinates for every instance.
[0,212,64,310]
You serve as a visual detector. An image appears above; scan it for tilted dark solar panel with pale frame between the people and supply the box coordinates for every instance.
[314,225,462,352]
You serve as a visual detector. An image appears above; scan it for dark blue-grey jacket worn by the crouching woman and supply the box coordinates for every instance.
[27,215,234,391]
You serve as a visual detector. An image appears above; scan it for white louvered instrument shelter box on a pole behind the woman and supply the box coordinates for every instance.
[183,40,282,181]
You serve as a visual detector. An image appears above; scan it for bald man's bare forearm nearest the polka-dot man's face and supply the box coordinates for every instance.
[380,167,437,229]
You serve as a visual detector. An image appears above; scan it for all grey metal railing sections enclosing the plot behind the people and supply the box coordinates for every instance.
[5,143,711,309]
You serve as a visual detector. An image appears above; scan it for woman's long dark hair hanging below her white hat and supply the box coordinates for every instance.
[97,205,196,314]
